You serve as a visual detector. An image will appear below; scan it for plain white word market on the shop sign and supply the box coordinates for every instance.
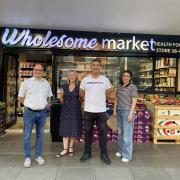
[102,36,155,51]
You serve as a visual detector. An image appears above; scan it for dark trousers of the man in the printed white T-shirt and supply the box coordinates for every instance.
[84,112,107,153]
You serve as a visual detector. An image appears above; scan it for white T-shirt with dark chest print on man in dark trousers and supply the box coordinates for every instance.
[80,75,111,113]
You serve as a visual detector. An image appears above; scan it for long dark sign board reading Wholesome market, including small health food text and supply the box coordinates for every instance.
[0,28,180,54]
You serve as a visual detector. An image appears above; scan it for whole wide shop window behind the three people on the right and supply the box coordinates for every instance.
[57,56,153,93]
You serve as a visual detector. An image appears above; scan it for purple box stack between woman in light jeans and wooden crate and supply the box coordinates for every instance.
[133,104,151,144]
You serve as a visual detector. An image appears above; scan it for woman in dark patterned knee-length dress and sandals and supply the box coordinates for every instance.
[56,70,82,157]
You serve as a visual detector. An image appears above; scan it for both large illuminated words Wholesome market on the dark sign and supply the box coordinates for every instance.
[1,28,156,51]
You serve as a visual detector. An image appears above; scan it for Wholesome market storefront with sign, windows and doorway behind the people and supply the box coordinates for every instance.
[0,27,180,143]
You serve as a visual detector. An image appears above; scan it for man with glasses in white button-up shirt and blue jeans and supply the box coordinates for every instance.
[18,64,52,167]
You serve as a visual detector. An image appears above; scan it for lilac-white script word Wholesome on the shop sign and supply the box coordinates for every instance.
[2,28,98,49]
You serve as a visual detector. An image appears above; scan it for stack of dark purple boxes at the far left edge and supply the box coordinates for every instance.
[0,102,6,136]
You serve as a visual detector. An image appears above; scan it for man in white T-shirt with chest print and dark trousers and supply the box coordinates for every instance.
[80,59,111,164]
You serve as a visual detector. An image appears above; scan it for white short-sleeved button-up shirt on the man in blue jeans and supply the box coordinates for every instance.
[18,77,53,110]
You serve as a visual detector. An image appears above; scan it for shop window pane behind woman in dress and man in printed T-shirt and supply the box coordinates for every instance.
[57,56,121,94]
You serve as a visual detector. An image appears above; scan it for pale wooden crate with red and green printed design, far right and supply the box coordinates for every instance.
[147,104,180,144]
